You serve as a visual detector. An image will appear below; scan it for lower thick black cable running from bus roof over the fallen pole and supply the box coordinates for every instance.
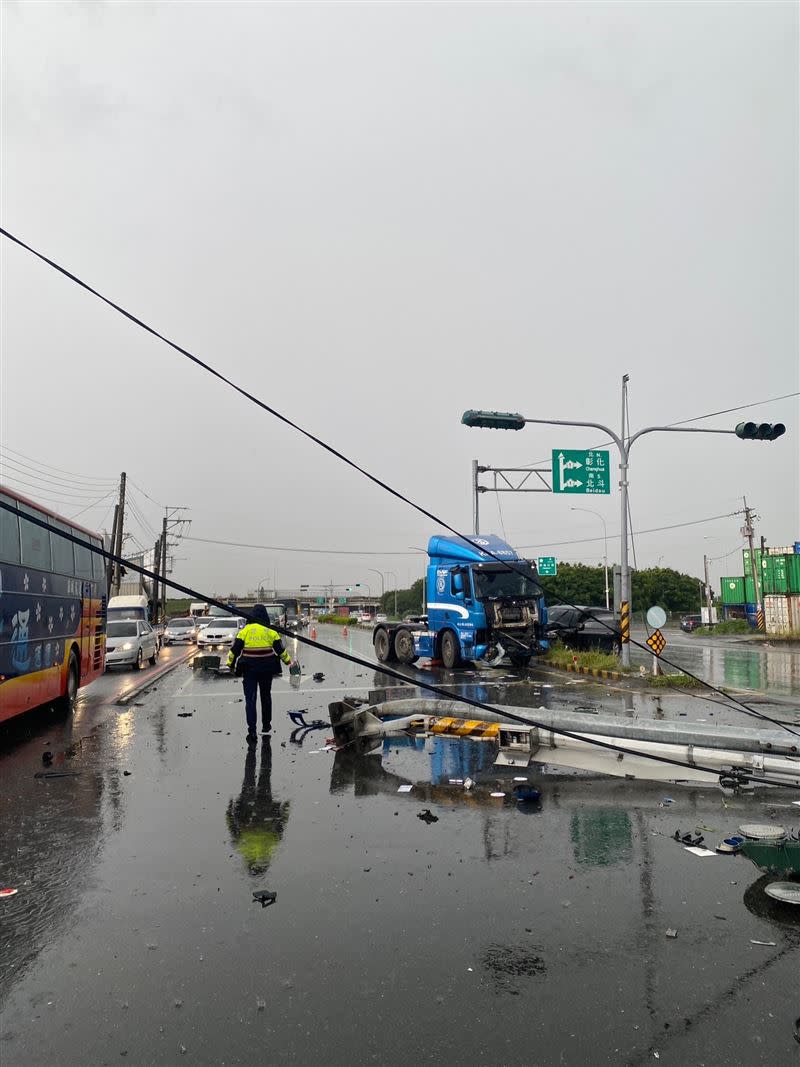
[0,499,800,785]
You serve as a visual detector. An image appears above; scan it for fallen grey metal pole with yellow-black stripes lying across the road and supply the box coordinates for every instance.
[329,699,800,787]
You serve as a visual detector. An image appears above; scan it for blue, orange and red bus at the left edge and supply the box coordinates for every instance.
[0,485,107,722]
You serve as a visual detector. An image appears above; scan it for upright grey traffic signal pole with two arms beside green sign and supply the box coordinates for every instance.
[461,375,786,667]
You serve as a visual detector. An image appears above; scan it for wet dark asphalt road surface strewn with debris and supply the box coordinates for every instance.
[0,627,800,1067]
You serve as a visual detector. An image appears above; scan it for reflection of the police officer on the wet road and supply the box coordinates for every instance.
[225,737,289,875]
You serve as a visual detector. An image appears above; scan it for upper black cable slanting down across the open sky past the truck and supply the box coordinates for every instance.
[0,227,794,733]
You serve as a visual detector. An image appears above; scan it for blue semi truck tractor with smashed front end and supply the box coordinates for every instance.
[372,534,547,670]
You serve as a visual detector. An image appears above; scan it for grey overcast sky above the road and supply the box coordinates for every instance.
[0,2,800,592]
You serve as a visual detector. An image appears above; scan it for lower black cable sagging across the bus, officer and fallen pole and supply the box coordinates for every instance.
[0,499,800,789]
